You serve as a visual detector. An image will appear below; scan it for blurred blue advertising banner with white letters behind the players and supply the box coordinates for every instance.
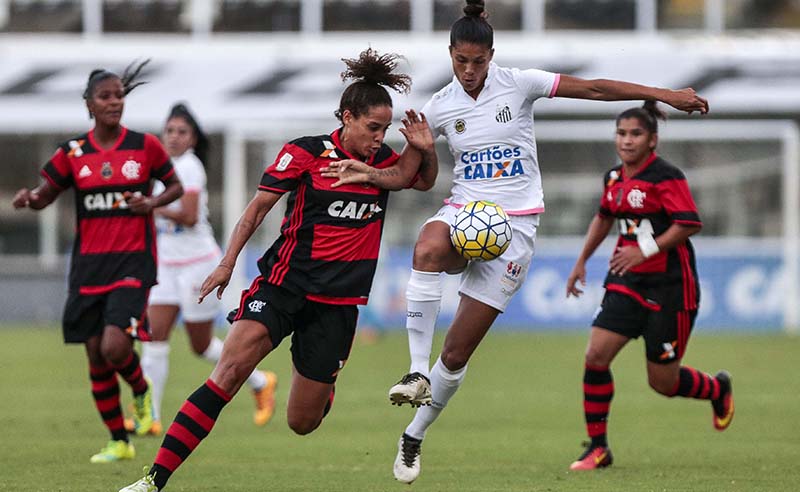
[248,240,786,331]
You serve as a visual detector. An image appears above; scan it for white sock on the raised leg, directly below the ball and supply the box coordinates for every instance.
[406,270,442,376]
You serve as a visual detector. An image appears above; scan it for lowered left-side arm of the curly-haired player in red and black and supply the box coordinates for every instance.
[197,190,281,303]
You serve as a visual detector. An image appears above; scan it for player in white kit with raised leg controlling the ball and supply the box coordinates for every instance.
[322,0,708,483]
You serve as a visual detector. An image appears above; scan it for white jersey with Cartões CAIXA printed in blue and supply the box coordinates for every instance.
[422,63,560,215]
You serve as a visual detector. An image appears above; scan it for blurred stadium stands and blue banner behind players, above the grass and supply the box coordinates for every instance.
[0,0,800,331]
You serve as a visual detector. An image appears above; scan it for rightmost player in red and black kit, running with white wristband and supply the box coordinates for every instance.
[567,101,733,470]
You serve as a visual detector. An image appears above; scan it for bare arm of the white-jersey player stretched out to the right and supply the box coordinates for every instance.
[556,75,708,114]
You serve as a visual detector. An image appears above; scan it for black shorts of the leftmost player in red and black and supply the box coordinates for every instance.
[62,287,150,343]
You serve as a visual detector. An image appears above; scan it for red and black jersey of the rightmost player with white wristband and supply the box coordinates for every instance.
[599,154,702,310]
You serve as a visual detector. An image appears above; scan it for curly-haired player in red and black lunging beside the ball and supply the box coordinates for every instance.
[121,49,435,492]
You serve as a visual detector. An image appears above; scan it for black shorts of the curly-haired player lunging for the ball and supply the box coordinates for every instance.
[228,277,358,384]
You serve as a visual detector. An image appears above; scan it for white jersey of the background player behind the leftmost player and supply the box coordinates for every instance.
[153,150,219,266]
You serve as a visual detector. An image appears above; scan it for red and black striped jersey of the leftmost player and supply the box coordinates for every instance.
[41,127,174,295]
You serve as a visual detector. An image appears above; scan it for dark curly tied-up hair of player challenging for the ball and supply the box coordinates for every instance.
[334,48,411,121]
